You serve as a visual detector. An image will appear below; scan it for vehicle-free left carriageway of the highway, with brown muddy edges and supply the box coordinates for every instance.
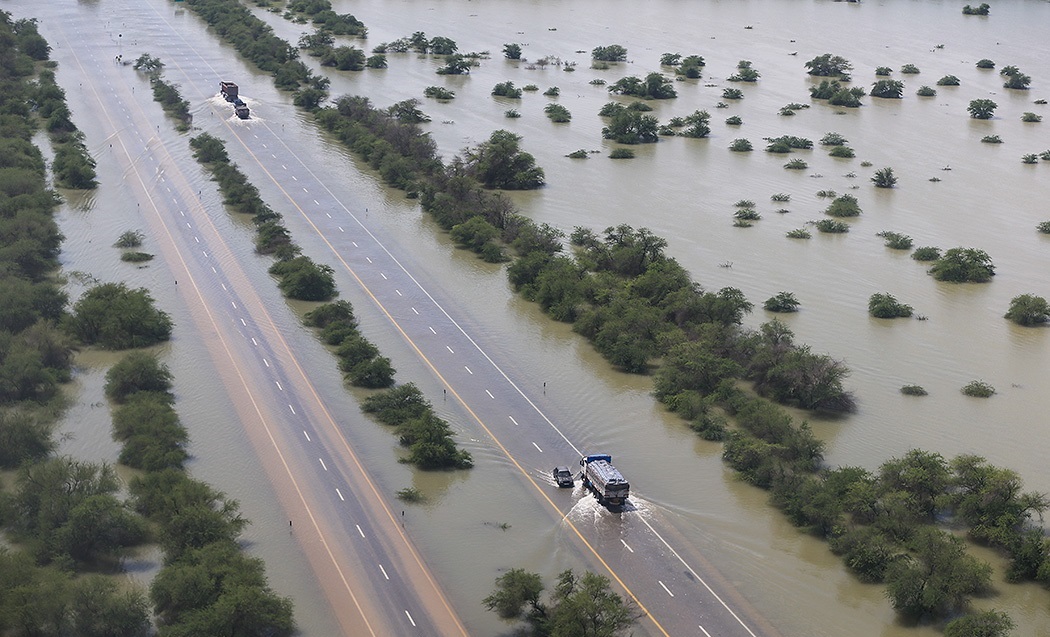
[42,9,466,635]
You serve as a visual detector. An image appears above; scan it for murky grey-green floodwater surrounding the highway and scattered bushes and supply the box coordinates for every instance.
[24,0,1050,637]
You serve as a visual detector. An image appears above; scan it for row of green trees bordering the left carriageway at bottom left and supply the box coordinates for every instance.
[105,352,295,637]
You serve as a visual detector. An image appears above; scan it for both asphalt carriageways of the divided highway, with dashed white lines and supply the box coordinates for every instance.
[43,2,776,637]
